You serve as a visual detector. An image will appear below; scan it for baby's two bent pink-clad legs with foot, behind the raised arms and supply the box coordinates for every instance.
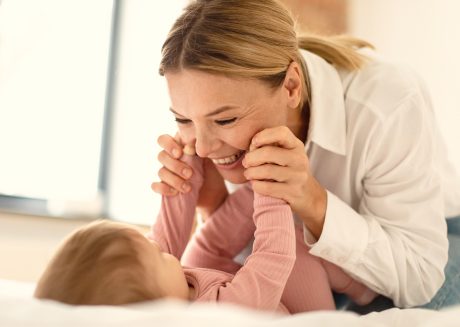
[174,155,377,313]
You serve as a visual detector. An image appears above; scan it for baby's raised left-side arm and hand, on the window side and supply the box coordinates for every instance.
[147,155,203,259]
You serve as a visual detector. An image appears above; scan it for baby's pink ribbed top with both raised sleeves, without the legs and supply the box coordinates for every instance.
[148,156,296,312]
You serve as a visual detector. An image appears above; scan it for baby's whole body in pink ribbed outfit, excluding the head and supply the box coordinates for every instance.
[150,156,375,313]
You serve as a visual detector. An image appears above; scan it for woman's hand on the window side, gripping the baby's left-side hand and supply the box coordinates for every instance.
[151,134,228,216]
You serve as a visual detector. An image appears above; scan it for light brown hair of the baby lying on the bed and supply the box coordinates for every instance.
[34,221,162,305]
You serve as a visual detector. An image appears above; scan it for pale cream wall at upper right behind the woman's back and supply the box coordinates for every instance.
[349,0,460,171]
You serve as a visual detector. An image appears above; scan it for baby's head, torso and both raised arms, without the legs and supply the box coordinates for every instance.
[35,156,295,312]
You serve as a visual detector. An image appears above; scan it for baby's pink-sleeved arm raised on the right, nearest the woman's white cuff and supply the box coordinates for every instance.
[217,193,296,310]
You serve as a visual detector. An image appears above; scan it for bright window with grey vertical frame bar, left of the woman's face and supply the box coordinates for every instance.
[0,0,186,224]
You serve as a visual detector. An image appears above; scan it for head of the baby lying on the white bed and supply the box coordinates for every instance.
[35,221,189,305]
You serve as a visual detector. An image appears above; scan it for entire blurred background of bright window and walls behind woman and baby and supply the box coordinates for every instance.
[0,0,460,281]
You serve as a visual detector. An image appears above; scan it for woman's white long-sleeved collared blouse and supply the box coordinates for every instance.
[303,51,460,307]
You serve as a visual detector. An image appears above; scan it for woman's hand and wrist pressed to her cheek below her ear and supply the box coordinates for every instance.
[243,126,327,239]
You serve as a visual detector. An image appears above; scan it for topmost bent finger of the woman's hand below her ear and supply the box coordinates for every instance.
[249,126,304,151]
